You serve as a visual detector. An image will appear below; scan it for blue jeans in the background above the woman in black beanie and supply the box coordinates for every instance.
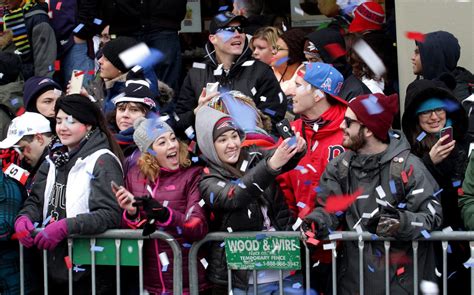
[61,42,94,86]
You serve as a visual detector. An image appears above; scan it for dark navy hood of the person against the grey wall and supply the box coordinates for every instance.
[416,31,461,80]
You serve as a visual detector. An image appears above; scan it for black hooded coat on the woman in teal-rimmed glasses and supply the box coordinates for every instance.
[402,80,469,229]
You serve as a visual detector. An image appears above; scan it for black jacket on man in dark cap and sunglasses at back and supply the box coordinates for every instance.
[176,41,287,135]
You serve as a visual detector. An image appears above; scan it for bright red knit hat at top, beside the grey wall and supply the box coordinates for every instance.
[349,2,385,33]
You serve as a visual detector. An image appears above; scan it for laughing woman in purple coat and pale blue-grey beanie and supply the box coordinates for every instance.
[115,118,208,294]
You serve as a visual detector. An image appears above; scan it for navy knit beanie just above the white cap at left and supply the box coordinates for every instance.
[23,76,62,112]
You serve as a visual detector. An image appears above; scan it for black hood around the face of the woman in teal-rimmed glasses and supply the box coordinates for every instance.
[402,79,468,139]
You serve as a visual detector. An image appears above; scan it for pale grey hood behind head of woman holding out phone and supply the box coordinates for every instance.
[196,106,229,166]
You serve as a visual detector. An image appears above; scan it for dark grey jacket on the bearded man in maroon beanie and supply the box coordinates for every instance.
[307,134,442,294]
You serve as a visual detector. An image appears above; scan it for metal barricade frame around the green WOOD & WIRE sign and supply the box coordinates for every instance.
[189,231,311,295]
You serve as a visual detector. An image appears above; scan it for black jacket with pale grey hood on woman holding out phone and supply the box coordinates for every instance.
[196,107,304,290]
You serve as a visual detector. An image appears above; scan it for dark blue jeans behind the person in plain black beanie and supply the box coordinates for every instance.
[134,31,181,93]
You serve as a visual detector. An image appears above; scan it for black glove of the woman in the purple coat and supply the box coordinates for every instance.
[133,196,170,236]
